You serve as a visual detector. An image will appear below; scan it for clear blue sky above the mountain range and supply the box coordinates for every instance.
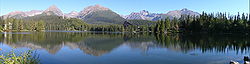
[0,0,249,15]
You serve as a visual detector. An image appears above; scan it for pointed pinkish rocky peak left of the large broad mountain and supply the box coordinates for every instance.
[43,5,63,16]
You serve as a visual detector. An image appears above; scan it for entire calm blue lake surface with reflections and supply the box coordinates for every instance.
[0,31,250,64]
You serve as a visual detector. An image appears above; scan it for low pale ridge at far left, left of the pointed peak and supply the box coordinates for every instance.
[3,10,43,18]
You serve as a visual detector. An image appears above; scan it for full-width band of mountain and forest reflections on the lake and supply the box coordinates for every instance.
[0,32,250,56]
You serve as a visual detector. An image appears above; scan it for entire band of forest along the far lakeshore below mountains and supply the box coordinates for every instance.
[0,12,250,33]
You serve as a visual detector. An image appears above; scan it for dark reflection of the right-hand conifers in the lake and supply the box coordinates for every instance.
[156,34,250,54]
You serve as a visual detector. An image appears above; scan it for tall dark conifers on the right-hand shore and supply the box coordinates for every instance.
[154,12,250,33]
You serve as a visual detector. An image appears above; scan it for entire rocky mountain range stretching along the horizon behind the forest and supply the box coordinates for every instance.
[3,5,200,24]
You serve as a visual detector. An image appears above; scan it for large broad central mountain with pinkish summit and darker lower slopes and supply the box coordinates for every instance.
[77,5,126,24]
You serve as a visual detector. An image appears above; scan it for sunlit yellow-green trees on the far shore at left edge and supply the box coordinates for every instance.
[0,18,45,31]
